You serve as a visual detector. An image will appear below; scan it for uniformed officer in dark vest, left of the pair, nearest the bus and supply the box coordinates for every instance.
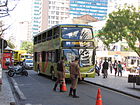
[53,57,65,92]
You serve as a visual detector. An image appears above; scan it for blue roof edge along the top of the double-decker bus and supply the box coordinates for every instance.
[33,24,92,37]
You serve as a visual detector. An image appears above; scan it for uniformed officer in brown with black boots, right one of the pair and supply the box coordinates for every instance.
[69,57,81,98]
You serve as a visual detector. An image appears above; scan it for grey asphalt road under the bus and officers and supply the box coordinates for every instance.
[10,70,140,105]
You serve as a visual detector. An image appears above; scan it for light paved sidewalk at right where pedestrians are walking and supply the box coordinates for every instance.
[85,70,140,99]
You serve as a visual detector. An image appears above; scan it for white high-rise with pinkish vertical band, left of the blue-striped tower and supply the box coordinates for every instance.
[32,0,69,36]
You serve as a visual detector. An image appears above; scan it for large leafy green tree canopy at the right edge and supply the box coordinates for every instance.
[99,5,140,56]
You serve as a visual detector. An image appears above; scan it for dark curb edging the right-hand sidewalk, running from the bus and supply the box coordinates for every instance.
[84,80,140,99]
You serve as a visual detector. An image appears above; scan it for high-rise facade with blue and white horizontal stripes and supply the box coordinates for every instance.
[70,0,108,20]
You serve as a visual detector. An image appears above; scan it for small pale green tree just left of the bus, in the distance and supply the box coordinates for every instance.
[20,41,33,54]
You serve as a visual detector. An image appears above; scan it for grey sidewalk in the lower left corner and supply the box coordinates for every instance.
[0,69,15,105]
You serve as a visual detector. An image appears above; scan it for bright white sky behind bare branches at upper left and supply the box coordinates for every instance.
[3,0,32,39]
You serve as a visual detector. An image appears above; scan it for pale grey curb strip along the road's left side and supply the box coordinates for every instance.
[7,75,27,100]
